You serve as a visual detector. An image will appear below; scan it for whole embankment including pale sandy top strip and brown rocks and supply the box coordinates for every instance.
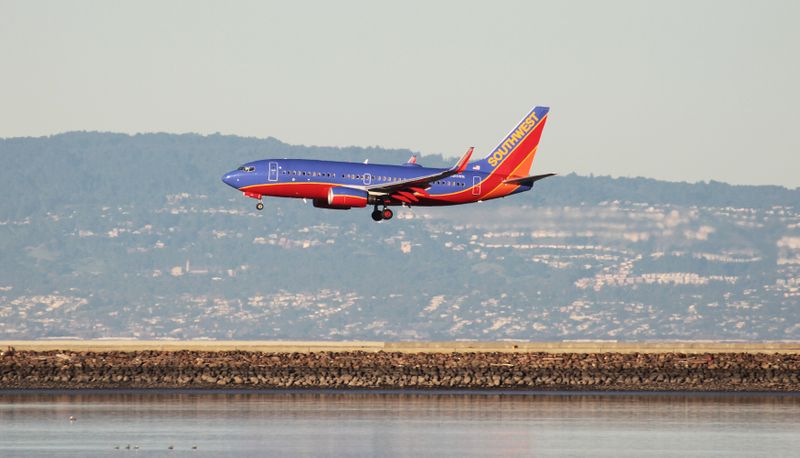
[0,341,800,391]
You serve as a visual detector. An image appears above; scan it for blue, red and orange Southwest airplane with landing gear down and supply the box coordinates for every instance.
[222,106,555,221]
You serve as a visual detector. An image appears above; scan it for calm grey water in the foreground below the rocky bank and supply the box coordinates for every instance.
[0,391,800,457]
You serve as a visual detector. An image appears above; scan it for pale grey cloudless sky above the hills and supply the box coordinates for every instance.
[0,0,800,187]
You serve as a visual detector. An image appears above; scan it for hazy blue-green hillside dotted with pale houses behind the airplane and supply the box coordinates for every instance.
[0,132,800,340]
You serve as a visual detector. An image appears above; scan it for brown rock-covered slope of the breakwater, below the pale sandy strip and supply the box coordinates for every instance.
[0,350,800,391]
